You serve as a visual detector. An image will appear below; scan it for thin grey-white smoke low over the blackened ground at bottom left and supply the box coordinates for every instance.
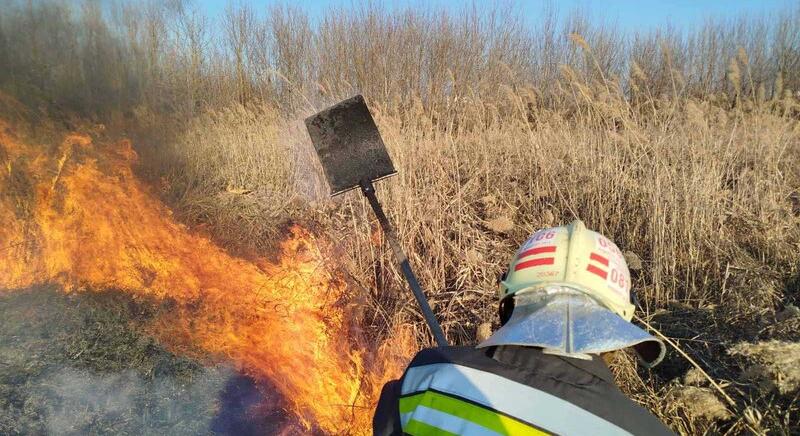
[29,367,242,435]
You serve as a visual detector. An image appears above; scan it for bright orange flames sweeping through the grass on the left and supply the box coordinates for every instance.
[0,120,413,433]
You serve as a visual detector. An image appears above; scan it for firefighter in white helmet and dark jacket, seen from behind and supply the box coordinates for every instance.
[373,221,672,435]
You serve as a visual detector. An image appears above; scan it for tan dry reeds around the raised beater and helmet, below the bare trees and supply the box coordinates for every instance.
[152,82,800,433]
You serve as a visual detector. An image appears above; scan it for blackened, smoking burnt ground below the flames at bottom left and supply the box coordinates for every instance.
[0,287,300,435]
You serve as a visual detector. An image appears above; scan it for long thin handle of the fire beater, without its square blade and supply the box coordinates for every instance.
[359,180,449,347]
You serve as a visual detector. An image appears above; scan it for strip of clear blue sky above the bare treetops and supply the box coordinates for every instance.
[197,0,798,31]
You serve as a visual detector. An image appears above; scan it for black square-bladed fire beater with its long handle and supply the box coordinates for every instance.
[306,95,447,346]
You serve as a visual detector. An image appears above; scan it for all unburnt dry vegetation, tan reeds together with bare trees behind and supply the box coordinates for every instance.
[0,1,800,434]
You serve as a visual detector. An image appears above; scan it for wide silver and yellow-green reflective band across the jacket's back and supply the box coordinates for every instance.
[399,363,629,435]
